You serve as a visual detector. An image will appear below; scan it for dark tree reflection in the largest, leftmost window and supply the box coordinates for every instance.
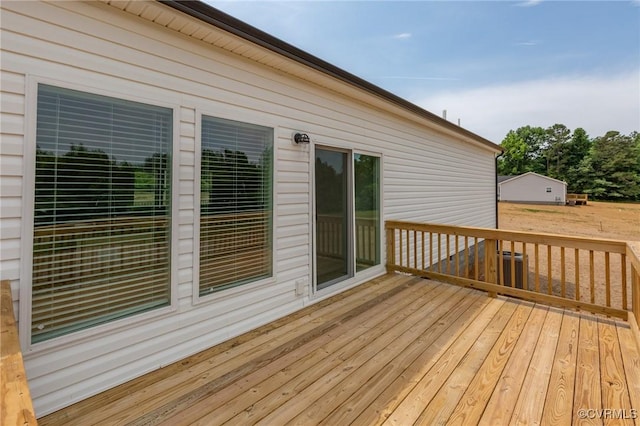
[35,144,170,225]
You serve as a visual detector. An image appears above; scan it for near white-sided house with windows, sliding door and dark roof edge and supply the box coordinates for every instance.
[0,1,501,416]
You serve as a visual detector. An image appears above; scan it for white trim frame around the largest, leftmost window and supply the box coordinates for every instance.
[19,74,180,352]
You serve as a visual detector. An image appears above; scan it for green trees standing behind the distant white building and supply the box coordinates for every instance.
[498,124,640,201]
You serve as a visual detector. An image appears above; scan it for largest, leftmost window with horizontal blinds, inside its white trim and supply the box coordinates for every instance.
[31,84,173,343]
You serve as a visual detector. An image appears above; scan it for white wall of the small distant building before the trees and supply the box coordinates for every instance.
[499,174,567,204]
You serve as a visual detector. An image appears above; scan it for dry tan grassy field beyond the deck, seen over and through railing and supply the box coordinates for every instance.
[498,201,640,307]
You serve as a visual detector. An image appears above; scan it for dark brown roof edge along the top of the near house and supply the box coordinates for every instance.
[157,0,503,152]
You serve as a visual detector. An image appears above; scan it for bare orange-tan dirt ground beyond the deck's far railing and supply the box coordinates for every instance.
[498,201,640,309]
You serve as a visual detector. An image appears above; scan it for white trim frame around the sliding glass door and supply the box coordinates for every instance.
[308,141,387,303]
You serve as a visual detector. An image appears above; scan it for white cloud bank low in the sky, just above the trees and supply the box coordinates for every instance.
[414,70,640,143]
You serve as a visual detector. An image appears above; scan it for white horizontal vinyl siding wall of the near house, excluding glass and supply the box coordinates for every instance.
[0,2,496,416]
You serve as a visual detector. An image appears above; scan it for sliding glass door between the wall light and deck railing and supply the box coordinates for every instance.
[315,147,380,290]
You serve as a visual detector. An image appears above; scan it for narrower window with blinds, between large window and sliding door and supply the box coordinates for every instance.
[200,116,273,296]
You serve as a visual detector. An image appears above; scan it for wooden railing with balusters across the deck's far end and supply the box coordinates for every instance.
[385,221,640,332]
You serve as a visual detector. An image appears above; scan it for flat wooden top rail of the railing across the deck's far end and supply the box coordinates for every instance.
[385,220,627,253]
